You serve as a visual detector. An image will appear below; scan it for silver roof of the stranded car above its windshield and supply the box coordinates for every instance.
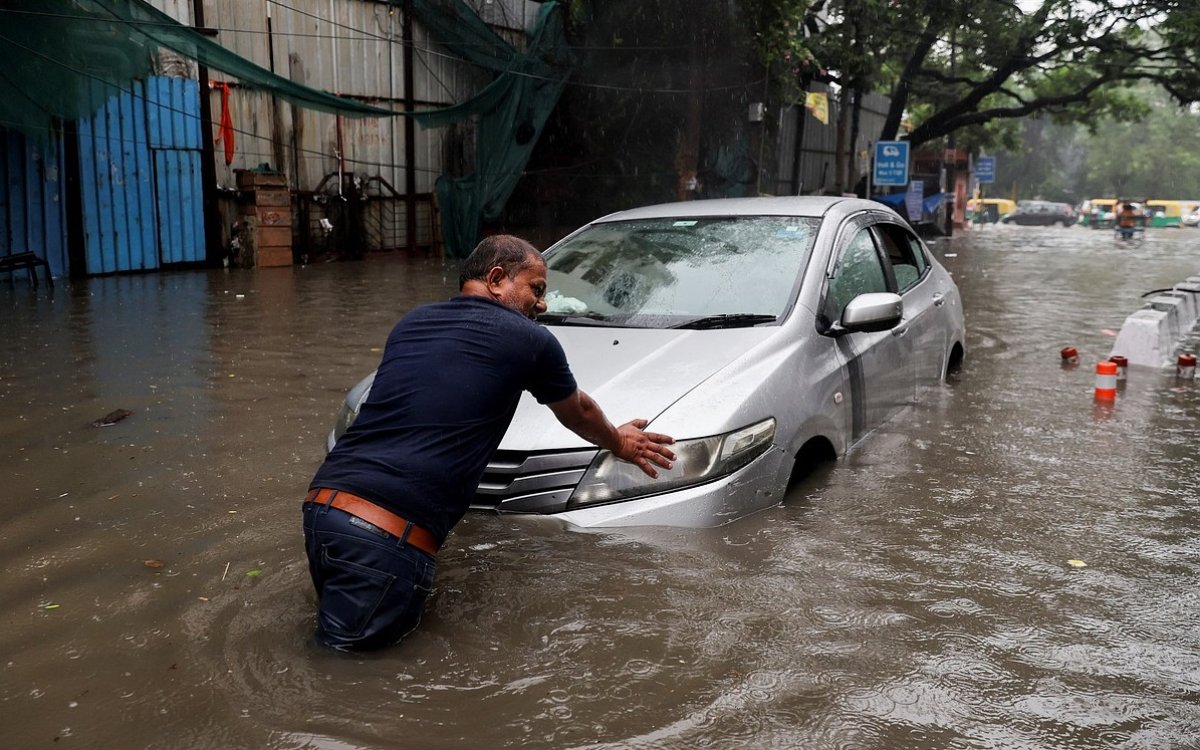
[592,196,895,223]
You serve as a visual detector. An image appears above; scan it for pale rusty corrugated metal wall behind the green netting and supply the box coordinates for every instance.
[204,0,539,193]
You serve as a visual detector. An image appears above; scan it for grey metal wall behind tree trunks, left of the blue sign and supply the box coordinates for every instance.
[774,84,890,196]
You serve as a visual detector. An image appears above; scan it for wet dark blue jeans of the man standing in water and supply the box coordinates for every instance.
[304,503,437,650]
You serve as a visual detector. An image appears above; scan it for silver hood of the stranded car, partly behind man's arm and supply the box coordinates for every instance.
[500,325,781,451]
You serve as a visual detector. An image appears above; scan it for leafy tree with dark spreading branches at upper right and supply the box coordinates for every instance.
[798,0,1200,146]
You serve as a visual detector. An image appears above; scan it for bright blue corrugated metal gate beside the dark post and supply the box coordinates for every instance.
[79,77,204,275]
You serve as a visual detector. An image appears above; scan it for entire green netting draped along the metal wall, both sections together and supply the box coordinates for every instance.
[0,0,571,257]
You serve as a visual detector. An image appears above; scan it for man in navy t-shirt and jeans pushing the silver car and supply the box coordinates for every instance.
[304,235,674,650]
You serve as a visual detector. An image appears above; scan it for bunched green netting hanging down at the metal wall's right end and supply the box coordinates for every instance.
[413,0,571,258]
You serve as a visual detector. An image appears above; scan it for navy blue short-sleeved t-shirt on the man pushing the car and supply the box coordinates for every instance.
[311,296,576,541]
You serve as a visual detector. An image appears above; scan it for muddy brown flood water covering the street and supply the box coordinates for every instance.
[0,227,1200,750]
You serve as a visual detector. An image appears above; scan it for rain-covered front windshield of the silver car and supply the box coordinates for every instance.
[539,216,820,328]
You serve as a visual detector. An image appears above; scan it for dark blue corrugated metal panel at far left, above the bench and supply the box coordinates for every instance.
[0,130,67,276]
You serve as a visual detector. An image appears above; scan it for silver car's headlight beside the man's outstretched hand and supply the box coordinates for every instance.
[566,419,775,510]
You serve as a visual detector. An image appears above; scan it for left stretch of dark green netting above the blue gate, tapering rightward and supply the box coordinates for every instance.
[0,0,395,137]
